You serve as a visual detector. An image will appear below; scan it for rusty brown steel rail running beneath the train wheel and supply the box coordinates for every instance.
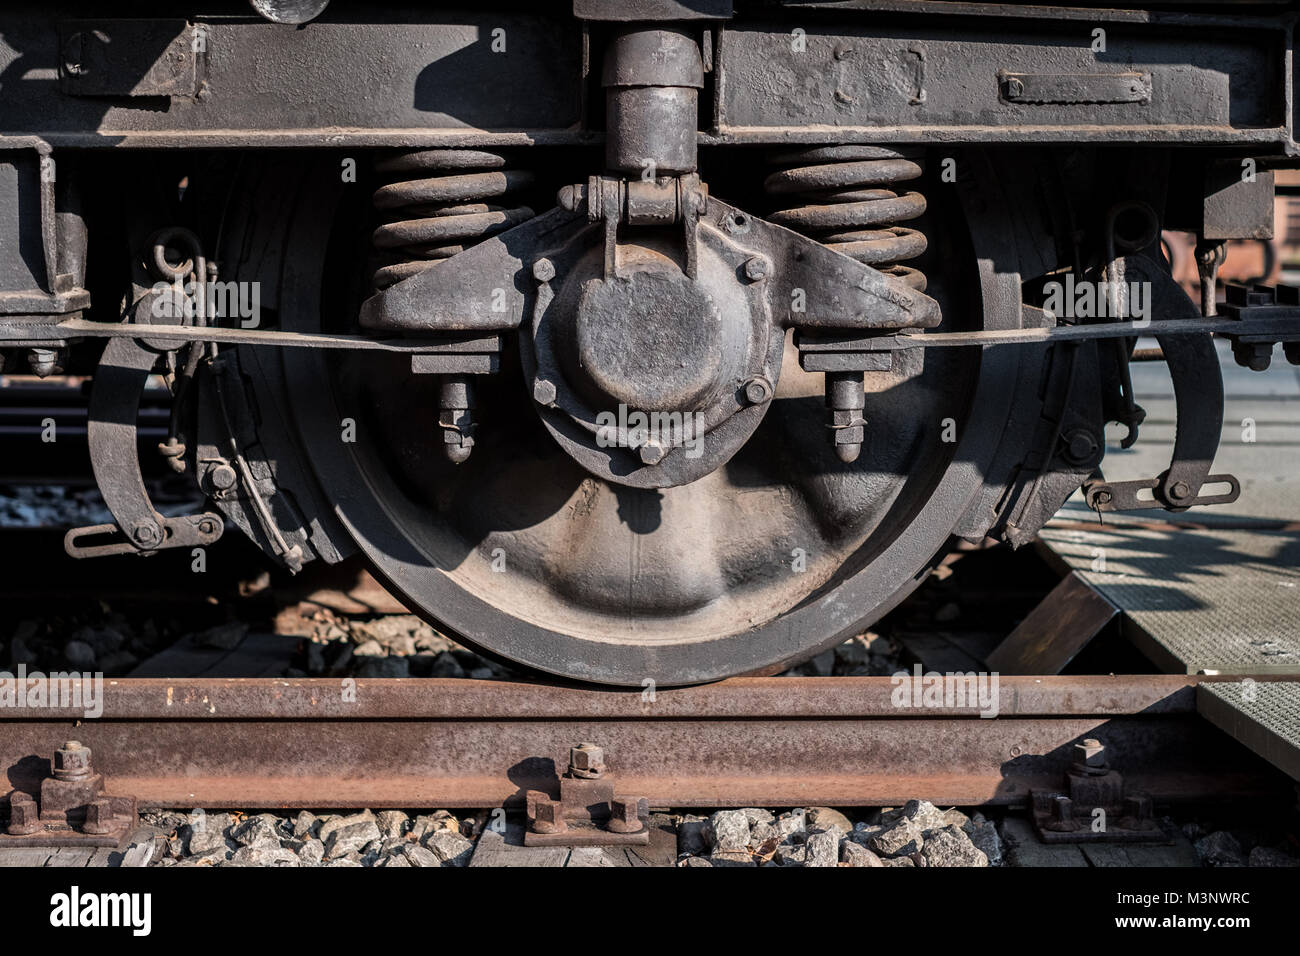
[0,675,1284,808]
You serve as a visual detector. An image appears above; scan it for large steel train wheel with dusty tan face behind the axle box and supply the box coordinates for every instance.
[210,155,1044,687]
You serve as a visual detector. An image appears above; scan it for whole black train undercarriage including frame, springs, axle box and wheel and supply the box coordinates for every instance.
[0,0,1300,685]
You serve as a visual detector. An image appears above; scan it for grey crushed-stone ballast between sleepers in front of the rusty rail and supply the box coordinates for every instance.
[78,800,1300,869]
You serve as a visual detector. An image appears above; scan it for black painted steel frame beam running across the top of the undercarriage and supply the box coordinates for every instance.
[0,0,1296,155]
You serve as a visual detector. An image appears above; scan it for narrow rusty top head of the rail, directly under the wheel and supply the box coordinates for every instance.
[0,675,1227,717]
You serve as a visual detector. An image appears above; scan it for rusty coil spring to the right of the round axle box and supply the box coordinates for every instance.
[763,146,927,291]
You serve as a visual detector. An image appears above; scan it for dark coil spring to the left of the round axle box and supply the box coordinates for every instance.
[373,150,534,289]
